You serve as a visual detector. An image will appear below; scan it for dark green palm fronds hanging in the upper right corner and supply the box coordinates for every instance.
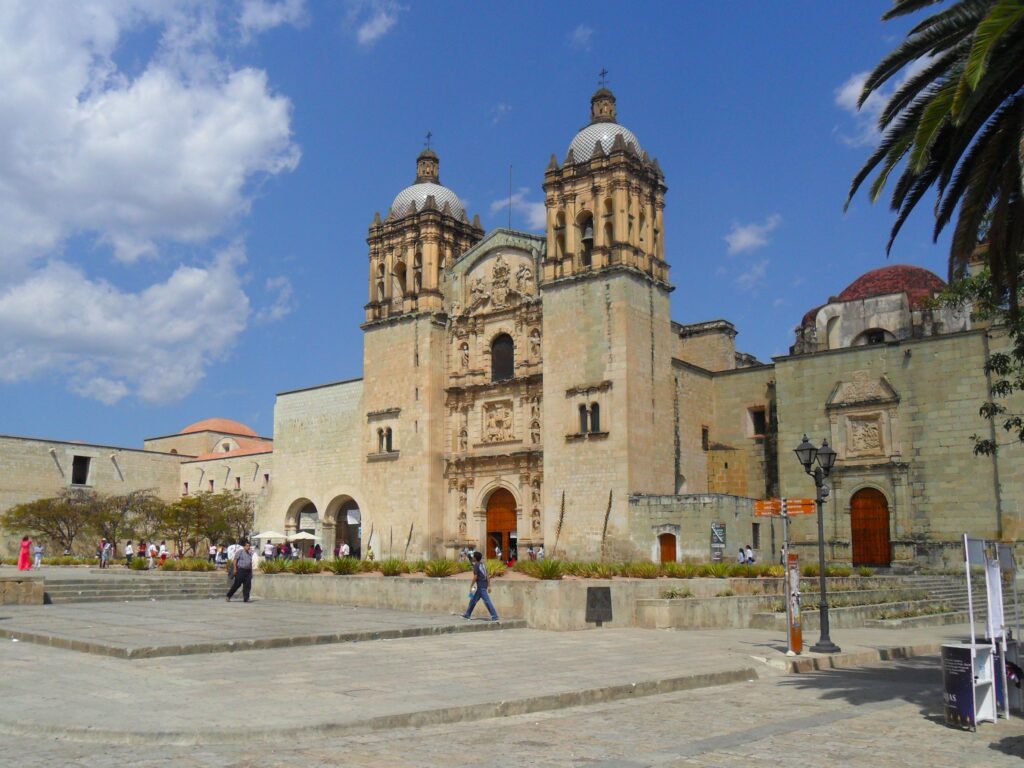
[846,0,1024,319]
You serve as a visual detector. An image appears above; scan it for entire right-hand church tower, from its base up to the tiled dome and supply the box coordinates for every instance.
[540,85,675,559]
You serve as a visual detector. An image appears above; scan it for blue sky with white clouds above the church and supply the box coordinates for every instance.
[0,0,947,446]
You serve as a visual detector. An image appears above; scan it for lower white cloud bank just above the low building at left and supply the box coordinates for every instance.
[0,244,249,403]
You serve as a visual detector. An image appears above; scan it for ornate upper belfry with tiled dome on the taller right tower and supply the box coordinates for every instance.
[544,86,669,283]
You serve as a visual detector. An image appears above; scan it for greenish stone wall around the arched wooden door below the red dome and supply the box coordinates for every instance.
[776,331,1021,564]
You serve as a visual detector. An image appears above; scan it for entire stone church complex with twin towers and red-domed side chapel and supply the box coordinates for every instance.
[0,88,1024,565]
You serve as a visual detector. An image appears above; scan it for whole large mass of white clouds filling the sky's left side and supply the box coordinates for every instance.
[0,0,299,402]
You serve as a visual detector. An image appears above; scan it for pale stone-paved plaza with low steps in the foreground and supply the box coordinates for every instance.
[0,569,1024,768]
